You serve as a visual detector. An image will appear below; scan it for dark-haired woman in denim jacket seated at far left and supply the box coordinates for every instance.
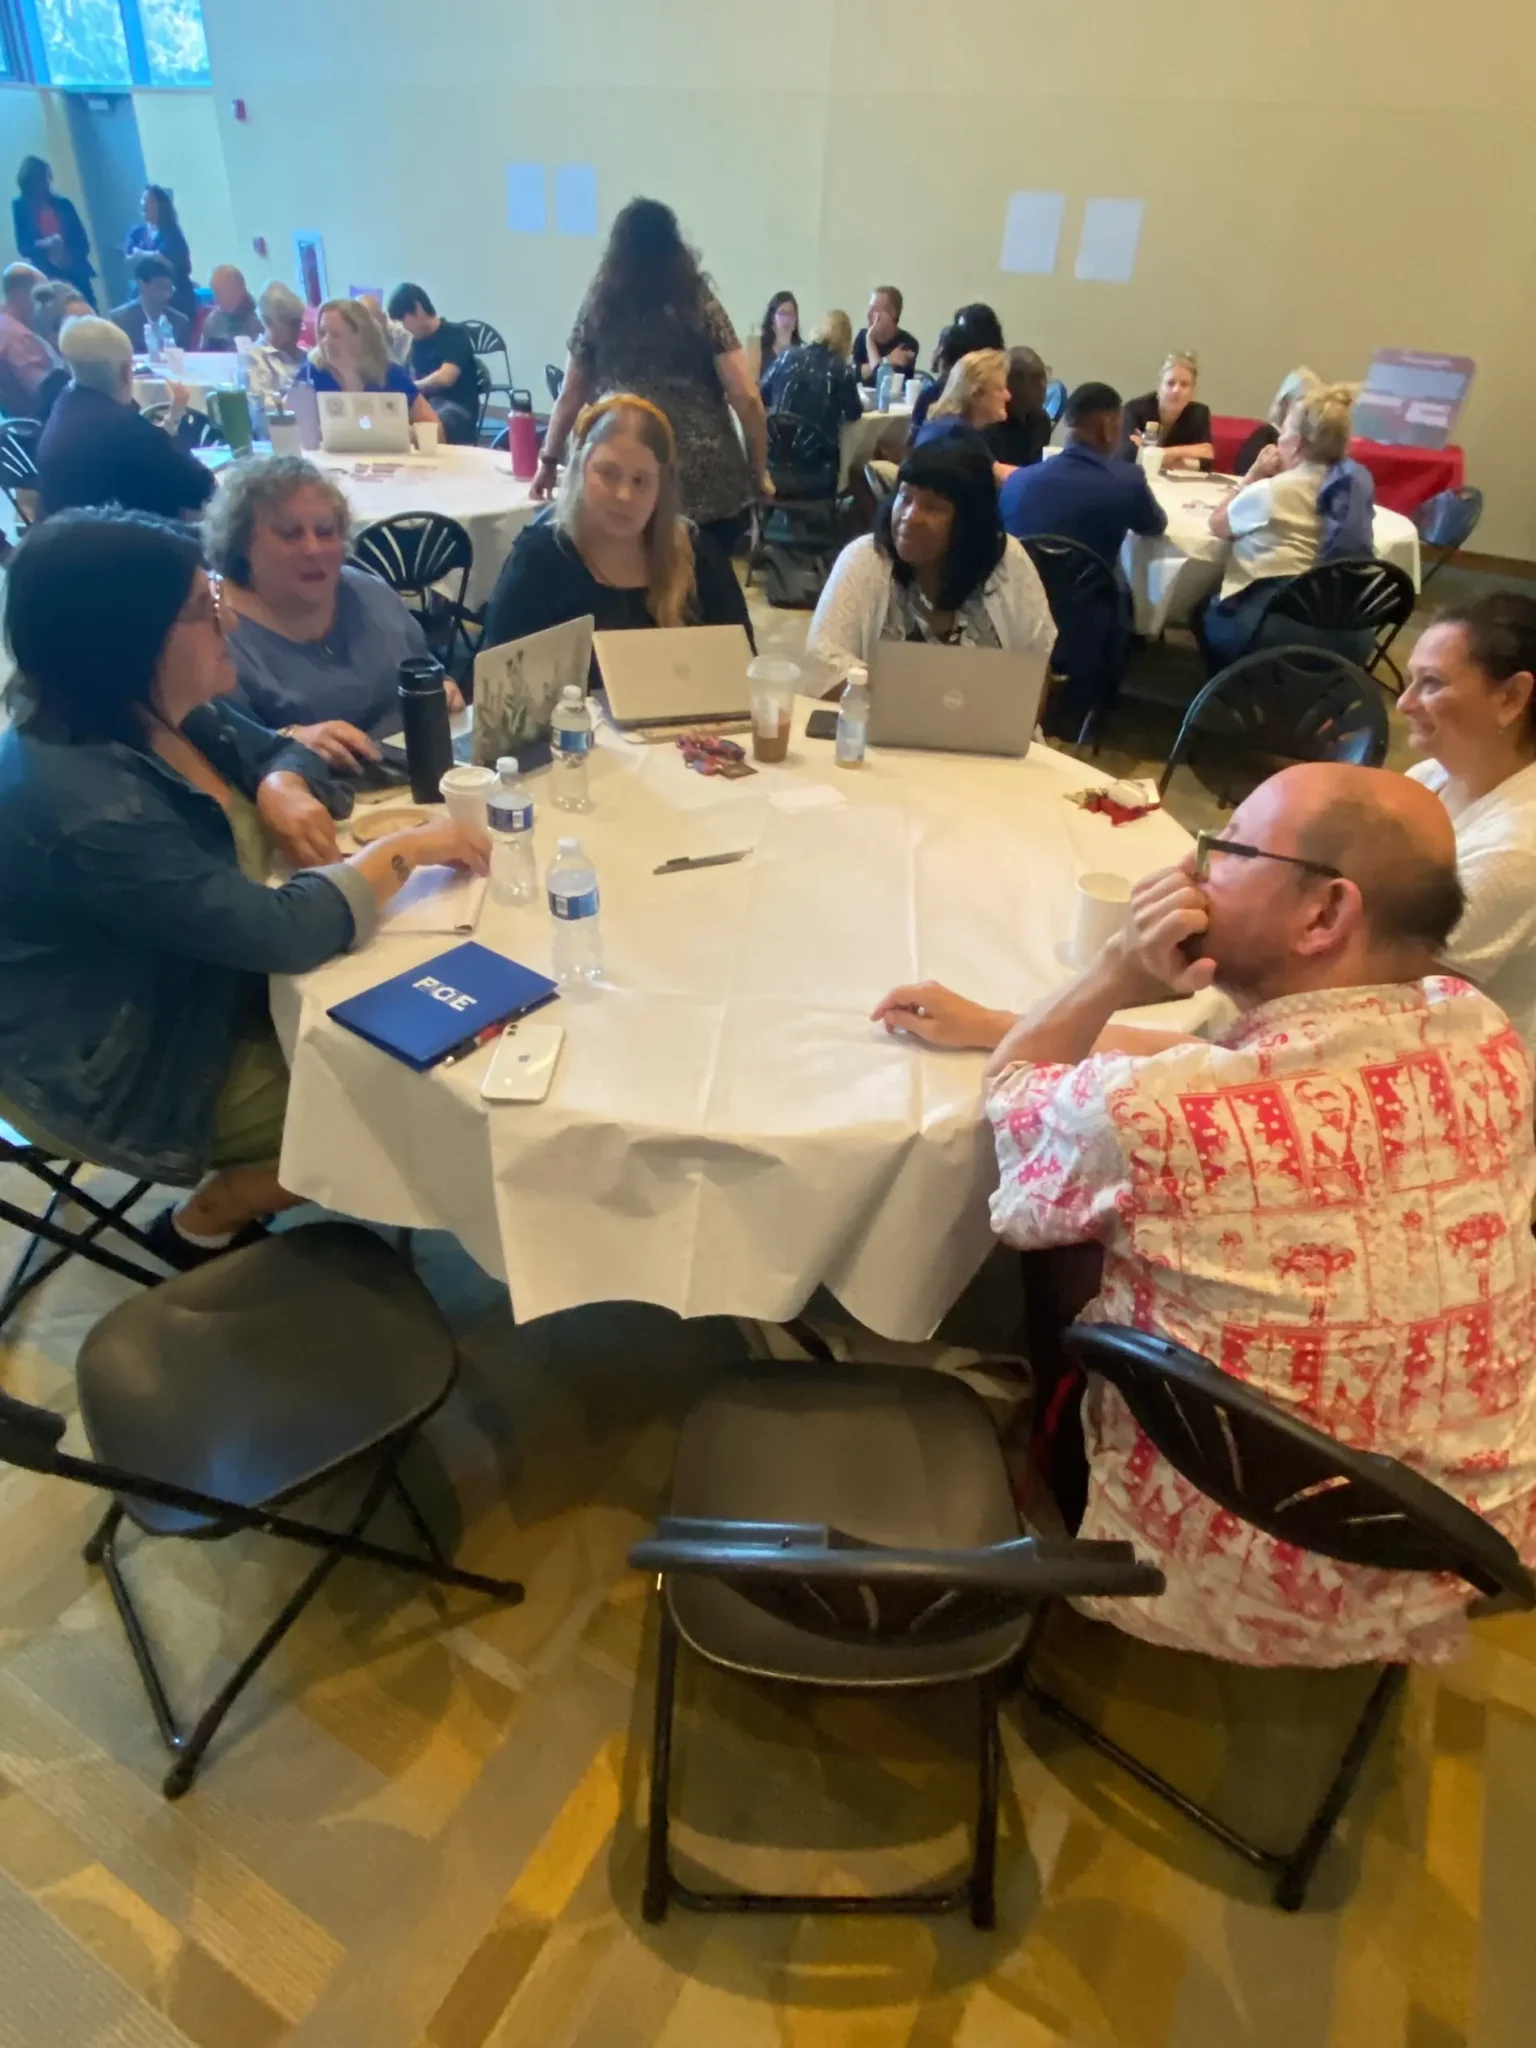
[0,510,489,1268]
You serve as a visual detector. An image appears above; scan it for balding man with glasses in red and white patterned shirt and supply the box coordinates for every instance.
[874,762,1536,1665]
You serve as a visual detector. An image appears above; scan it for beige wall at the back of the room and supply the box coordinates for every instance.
[135,0,1536,557]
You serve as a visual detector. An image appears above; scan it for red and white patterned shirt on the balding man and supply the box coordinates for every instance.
[987,977,1536,1665]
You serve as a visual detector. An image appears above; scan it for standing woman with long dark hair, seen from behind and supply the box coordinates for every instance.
[530,199,772,553]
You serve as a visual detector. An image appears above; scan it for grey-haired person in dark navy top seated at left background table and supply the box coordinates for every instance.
[37,315,213,518]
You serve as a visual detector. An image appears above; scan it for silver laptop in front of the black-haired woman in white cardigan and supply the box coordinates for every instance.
[868,641,1047,756]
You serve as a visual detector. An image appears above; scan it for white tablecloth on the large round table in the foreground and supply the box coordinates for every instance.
[272,700,1212,1339]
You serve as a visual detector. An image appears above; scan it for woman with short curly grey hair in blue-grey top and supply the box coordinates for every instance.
[203,455,463,772]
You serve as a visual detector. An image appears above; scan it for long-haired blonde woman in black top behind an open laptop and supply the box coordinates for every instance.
[483,391,748,684]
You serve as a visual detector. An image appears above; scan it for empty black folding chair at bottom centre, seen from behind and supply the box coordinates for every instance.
[629,1364,1161,1927]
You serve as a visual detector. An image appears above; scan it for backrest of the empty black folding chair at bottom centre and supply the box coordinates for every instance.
[629,1516,1163,1645]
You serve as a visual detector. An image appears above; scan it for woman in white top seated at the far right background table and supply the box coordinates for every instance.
[1194,385,1354,676]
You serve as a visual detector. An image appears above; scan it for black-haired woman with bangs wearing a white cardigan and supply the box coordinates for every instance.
[805,440,1057,682]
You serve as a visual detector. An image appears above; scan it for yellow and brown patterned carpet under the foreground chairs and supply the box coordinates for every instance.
[0,1187,1536,2048]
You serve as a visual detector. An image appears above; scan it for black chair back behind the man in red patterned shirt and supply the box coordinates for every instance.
[1063,1323,1536,1608]
